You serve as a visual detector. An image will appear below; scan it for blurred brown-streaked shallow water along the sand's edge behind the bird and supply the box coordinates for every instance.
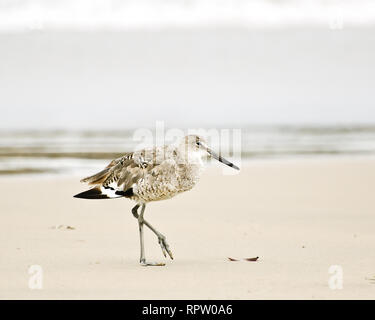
[0,125,375,176]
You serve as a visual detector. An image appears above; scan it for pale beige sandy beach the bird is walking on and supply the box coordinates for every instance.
[0,158,375,299]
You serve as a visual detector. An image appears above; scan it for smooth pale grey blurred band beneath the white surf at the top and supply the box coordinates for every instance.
[0,0,375,129]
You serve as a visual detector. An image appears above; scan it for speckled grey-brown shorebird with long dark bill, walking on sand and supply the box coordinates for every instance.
[74,135,239,266]
